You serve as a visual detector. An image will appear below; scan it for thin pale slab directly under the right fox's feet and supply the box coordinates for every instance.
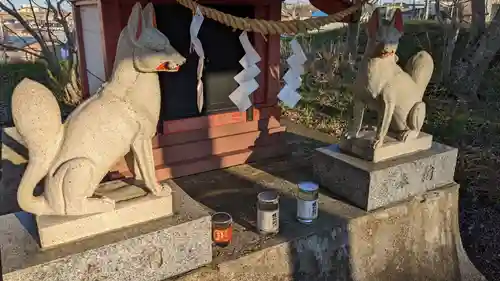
[340,131,432,162]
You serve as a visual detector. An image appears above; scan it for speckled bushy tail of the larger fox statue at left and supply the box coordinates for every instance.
[11,78,64,214]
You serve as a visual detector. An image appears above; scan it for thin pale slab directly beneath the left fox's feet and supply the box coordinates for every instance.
[36,181,173,249]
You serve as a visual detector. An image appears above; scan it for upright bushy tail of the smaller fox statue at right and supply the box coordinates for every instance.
[404,51,434,99]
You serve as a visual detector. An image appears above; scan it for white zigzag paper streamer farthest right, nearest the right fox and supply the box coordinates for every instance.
[278,39,307,108]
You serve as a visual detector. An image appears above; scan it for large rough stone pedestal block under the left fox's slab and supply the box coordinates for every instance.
[0,181,212,281]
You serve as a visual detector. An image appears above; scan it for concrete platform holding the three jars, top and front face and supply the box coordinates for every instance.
[166,154,485,281]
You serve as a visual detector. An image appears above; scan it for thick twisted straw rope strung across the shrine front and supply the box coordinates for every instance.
[177,0,366,35]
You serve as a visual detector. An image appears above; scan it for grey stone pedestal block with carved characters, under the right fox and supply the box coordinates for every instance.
[313,142,457,211]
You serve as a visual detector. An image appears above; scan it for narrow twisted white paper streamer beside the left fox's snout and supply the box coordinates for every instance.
[189,7,205,112]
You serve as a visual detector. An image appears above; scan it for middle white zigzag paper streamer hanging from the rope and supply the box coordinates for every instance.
[229,31,261,112]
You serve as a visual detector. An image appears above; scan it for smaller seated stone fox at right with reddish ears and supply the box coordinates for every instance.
[347,8,434,148]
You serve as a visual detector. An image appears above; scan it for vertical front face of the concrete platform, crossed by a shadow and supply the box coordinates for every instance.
[170,184,486,281]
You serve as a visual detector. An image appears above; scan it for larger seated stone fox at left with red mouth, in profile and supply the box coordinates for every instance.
[12,3,185,215]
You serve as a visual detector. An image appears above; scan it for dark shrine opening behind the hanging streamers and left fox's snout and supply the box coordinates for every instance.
[155,4,254,122]
